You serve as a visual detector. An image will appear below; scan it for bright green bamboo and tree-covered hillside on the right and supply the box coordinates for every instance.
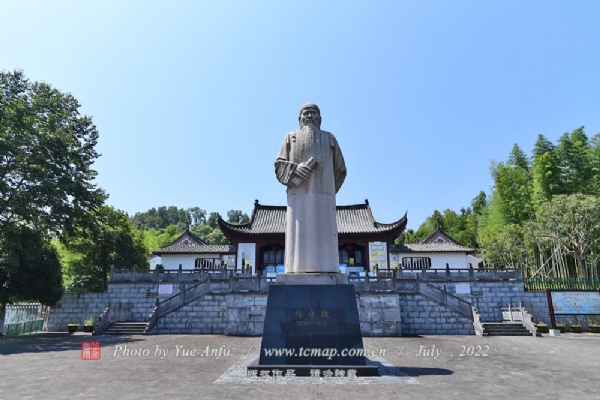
[398,127,600,278]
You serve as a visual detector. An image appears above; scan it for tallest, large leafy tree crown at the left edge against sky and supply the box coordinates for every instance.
[0,70,107,236]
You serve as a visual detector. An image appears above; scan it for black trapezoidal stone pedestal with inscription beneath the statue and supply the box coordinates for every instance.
[248,282,378,376]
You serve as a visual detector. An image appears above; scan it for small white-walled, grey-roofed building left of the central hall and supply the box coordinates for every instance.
[152,230,235,269]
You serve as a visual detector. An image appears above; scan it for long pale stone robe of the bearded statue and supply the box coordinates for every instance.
[275,127,346,273]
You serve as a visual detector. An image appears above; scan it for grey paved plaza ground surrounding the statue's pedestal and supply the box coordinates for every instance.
[0,333,600,400]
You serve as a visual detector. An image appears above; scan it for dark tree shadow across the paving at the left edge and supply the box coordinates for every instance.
[0,332,143,356]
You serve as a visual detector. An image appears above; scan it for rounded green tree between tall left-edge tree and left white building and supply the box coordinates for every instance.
[66,206,148,290]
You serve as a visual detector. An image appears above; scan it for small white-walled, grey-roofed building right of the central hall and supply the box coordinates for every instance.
[390,228,483,269]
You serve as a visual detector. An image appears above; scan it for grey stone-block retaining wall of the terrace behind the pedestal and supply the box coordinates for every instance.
[48,281,549,337]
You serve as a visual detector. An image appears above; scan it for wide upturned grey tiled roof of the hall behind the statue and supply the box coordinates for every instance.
[218,200,407,235]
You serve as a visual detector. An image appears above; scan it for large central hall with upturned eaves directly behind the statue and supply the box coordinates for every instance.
[218,200,407,275]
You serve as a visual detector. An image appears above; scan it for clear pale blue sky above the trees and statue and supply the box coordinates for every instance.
[0,0,600,229]
